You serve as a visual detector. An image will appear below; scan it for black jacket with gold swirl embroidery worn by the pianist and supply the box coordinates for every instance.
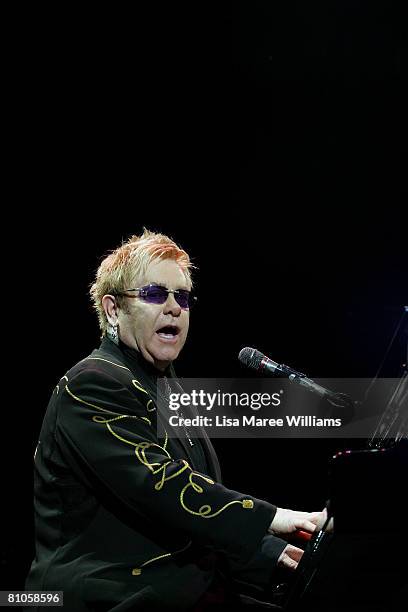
[26,338,285,612]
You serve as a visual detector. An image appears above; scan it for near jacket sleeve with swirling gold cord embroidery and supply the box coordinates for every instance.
[55,367,276,559]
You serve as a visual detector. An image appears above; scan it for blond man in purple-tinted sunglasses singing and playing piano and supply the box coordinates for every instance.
[26,230,323,612]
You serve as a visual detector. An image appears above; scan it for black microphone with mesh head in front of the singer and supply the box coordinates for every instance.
[238,347,354,408]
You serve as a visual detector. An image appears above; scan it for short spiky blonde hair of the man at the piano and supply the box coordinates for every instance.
[90,228,195,335]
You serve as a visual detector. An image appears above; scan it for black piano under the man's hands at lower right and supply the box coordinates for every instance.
[275,310,408,612]
